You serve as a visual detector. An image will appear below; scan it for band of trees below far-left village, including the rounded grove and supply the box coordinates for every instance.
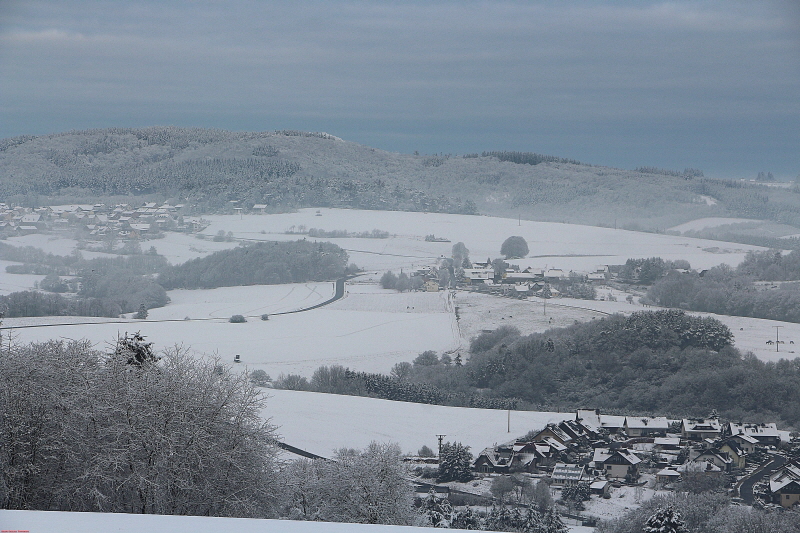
[0,240,356,317]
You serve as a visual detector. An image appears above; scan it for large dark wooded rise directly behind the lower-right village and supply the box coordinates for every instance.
[464,310,800,424]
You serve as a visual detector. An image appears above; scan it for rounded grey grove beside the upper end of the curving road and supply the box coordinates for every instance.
[158,240,347,289]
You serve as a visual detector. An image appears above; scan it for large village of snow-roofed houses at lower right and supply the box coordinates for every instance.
[472,409,800,507]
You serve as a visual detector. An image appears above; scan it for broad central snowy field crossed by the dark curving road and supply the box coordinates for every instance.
[3,283,461,377]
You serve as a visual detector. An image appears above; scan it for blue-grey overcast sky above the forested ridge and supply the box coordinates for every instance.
[0,0,800,179]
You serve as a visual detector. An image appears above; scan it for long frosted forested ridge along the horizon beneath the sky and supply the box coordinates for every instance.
[0,127,800,230]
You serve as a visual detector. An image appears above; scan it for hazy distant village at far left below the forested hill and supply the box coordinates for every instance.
[0,202,203,240]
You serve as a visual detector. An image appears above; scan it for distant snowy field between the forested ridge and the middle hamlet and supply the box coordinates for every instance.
[194,209,760,271]
